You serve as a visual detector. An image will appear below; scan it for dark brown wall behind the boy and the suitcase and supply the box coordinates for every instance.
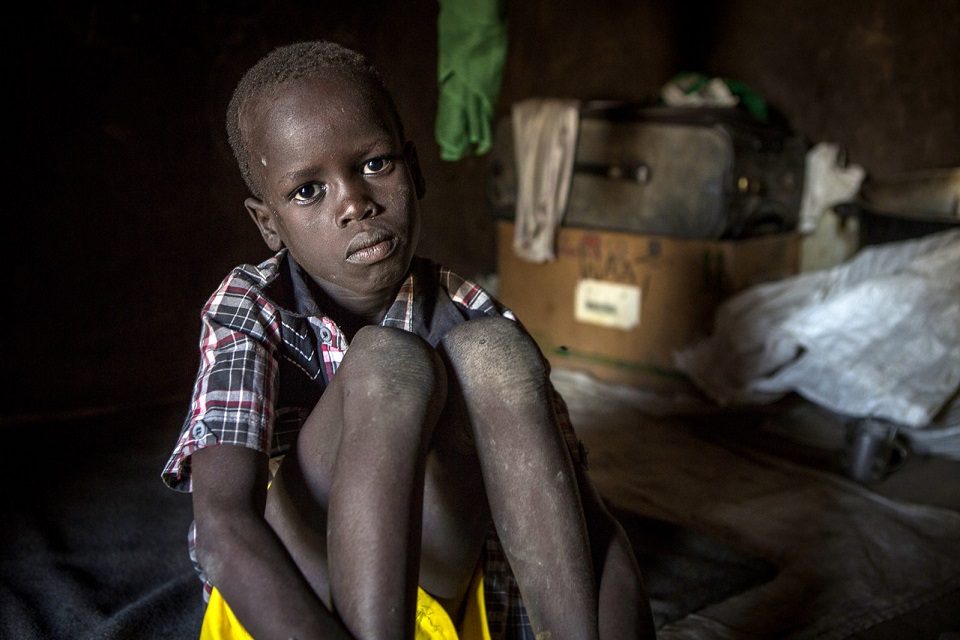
[9,0,960,420]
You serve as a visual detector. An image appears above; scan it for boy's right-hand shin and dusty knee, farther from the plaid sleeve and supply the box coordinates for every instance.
[441,318,598,640]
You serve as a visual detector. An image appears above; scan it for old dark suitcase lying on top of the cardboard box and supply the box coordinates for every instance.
[488,102,809,239]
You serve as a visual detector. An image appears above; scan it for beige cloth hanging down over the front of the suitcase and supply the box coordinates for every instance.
[511,98,580,262]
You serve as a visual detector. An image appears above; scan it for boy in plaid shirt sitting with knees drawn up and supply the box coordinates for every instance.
[163,42,652,640]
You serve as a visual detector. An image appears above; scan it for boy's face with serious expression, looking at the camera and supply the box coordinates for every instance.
[241,73,423,308]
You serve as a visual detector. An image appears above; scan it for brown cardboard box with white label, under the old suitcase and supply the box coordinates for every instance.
[497,220,800,389]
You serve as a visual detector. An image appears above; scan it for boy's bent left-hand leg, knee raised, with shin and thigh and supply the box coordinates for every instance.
[267,327,446,638]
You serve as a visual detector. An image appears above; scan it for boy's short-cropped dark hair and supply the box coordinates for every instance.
[227,41,405,198]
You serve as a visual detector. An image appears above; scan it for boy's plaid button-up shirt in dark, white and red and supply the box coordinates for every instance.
[162,250,585,640]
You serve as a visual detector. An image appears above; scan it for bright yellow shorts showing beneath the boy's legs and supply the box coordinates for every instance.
[200,569,490,640]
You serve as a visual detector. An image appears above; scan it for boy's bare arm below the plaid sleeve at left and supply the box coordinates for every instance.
[192,445,351,640]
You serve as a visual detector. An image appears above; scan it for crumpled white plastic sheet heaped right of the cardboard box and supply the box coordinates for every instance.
[676,229,960,427]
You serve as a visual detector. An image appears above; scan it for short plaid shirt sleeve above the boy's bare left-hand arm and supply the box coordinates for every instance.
[162,277,280,491]
